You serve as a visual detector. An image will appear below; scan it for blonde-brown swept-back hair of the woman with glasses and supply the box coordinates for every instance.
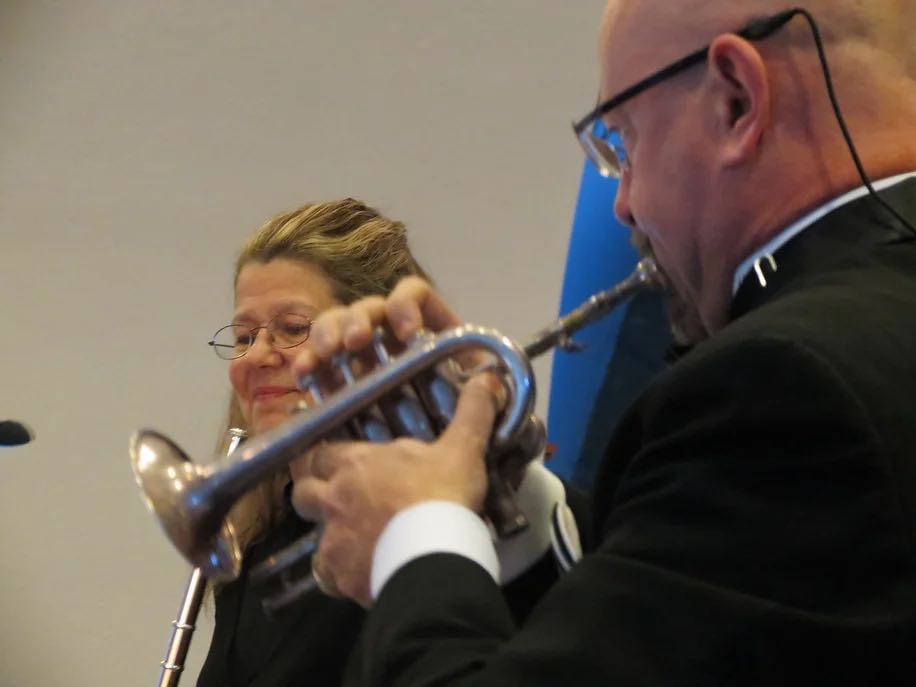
[226,198,428,550]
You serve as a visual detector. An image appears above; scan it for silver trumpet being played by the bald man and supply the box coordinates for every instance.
[130,259,663,596]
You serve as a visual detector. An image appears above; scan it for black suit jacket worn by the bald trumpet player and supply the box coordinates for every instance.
[348,180,916,687]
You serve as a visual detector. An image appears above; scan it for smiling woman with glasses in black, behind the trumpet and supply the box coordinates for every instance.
[197,198,426,687]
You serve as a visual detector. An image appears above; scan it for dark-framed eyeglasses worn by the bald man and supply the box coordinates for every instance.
[573,9,799,178]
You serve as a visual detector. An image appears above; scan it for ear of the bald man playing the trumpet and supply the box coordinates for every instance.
[708,34,771,167]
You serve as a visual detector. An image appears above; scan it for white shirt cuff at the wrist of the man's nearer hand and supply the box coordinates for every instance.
[369,501,500,601]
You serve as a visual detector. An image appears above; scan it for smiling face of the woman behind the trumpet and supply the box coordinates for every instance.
[229,259,340,434]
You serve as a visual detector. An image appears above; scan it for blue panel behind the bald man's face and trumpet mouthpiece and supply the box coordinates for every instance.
[547,163,669,485]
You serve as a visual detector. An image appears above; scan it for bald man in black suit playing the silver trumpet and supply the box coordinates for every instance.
[294,0,916,687]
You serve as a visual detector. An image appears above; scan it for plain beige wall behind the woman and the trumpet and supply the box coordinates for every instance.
[0,0,610,687]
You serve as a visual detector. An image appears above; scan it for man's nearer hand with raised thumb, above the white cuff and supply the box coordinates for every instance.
[292,376,497,606]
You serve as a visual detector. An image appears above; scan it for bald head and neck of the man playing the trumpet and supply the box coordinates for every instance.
[600,0,916,342]
